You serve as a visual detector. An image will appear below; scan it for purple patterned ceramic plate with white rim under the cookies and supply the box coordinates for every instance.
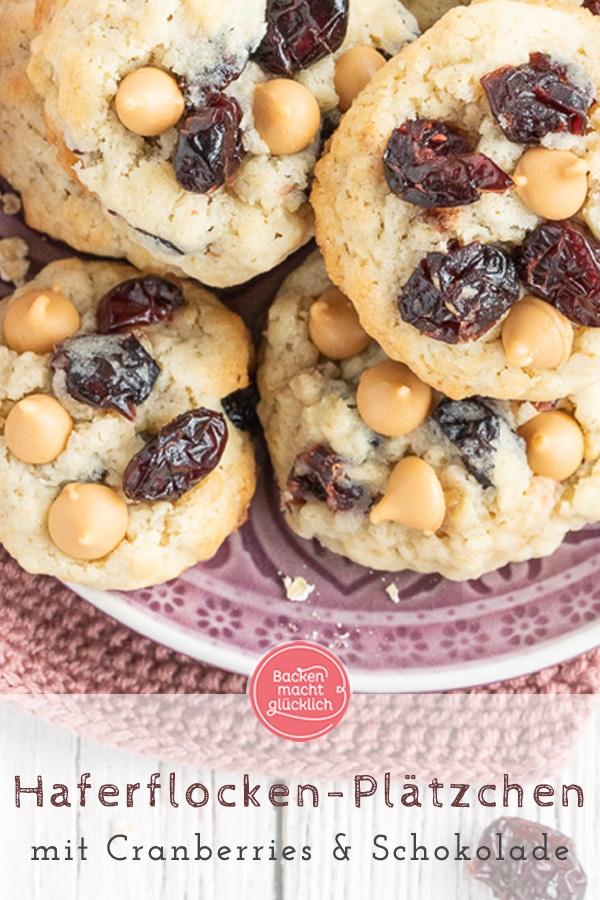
[0,186,600,692]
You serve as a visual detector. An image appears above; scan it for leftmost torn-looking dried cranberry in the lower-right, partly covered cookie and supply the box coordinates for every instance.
[287,444,366,512]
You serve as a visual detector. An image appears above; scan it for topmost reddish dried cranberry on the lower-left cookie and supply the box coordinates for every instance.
[96,275,185,334]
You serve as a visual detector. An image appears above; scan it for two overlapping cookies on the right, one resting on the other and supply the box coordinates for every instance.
[260,0,600,580]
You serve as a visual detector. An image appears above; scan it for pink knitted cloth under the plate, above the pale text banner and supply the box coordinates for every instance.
[0,549,600,694]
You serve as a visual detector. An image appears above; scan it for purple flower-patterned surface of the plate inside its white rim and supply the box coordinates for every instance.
[103,434,600,690]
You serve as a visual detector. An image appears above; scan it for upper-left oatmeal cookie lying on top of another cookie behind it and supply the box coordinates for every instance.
[29,0,417,287]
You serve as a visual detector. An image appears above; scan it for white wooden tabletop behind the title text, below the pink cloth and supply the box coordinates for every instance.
[0,701,600,900]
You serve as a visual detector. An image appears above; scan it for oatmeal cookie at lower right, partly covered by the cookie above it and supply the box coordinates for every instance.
[259,255,600,580]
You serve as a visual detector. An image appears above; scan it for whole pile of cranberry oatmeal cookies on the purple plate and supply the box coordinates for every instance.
[0,0,600,589]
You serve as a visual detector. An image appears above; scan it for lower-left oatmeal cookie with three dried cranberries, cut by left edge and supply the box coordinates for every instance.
[0,259,255,590]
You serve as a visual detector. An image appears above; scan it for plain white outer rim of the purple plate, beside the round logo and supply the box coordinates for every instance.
[65,582,600,694]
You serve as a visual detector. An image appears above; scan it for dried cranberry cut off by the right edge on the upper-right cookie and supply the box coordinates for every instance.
[515,219,600,328]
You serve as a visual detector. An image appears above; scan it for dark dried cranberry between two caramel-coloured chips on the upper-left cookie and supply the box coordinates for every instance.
[174,91,244,194]
